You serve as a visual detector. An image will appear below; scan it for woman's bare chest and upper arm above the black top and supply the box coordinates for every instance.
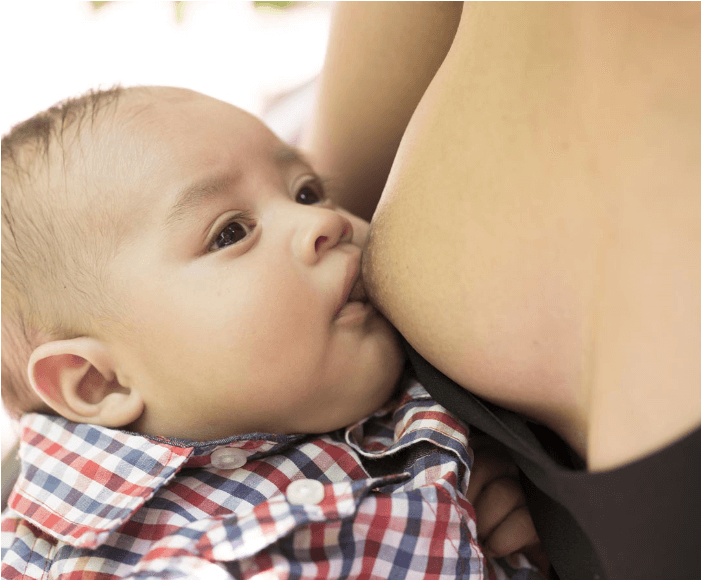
[303,2,700,471]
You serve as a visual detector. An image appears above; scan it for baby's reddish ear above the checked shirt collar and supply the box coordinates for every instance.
[27,337,144,428]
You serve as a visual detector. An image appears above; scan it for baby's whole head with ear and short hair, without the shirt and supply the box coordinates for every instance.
[2,87,402,440]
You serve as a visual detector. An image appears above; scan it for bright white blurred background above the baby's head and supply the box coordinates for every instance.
[0,0,332,456]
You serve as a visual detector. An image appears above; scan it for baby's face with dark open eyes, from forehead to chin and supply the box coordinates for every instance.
[102,89,402,439]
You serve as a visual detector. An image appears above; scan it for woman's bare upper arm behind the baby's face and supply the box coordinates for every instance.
[301,2,463,220]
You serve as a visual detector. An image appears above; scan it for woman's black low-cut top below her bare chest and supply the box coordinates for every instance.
[405,342,700,579]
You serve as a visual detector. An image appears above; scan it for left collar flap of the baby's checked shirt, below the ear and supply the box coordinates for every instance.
[8,414,301,548]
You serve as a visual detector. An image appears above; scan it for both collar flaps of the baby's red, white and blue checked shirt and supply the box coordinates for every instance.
[8,381,471,548]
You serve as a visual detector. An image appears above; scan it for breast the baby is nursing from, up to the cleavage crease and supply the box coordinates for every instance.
[363,4,596,440]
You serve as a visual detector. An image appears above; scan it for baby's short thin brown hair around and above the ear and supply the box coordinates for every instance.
[2,87,124,415]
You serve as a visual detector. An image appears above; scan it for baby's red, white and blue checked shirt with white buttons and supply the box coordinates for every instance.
[2,374,540,580]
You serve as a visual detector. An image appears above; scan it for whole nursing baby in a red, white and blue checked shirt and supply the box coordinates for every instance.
[2,87,544,579]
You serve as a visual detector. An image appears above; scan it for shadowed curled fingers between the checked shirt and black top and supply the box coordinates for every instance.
[467,436,548,572]
